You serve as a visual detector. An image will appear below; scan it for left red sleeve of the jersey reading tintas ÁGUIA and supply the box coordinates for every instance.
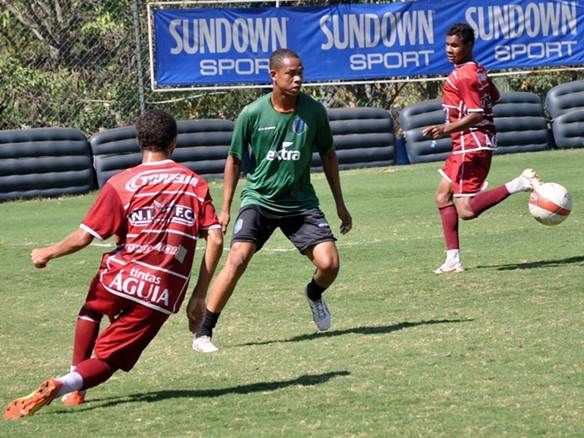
[81,183,126,240]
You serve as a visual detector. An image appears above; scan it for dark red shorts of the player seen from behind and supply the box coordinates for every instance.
[85,277,168,371]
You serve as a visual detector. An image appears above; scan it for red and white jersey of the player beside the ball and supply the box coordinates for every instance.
[442,61,500,154]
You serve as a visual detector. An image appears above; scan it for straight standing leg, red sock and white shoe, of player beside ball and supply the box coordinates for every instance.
[434,172,463,274]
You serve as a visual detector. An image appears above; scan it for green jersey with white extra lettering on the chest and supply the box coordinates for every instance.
[229,93,333,213]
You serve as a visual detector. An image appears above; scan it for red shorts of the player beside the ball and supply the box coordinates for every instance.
[439,150,493,197]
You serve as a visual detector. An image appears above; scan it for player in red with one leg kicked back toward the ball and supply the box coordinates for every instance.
[422,23,539,274]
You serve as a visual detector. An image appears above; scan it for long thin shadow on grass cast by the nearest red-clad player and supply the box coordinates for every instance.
[55,371,351,414]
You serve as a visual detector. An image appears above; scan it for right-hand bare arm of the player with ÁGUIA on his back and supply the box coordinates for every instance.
[187,228,223,333]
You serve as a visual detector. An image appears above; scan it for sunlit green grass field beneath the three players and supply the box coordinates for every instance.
[0,150,584,437]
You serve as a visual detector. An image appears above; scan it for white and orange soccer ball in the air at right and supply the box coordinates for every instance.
[528,183,572,225]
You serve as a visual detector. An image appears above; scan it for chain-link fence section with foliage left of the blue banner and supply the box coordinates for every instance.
[0,0,141,133]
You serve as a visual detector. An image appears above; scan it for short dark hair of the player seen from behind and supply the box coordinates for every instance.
[136,110,177,152]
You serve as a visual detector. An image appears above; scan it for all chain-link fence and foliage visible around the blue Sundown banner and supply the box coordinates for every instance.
[0,0,583,135]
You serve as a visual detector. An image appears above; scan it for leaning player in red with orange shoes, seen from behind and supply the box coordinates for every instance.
[4,111,223,420]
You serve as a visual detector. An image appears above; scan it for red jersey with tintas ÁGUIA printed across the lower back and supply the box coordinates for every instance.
[81,160,220,314]
